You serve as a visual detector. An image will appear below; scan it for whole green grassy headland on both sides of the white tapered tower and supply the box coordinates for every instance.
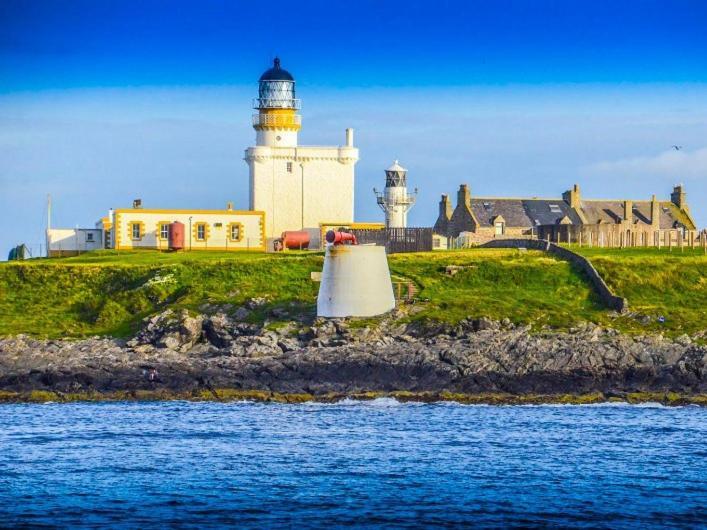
[0,245,707,337]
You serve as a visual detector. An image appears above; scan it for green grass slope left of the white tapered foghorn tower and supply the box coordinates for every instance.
[0,251,323,337]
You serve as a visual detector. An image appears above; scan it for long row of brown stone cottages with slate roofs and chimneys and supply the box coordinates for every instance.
[433,184,698,246]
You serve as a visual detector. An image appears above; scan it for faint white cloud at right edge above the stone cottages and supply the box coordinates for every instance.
[586,147,707,180]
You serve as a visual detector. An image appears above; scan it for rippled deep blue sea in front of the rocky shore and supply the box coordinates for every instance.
[0,399,707,529]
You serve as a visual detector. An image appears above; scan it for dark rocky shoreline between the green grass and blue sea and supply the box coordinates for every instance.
[0,301,707,405]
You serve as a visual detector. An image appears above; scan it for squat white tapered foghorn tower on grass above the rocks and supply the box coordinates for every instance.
[317,232,395,318]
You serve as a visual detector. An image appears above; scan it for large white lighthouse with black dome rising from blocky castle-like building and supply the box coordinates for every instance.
[245,58,358,243]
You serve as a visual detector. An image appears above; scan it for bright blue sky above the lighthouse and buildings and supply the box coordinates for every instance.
[0,0,707,257]
